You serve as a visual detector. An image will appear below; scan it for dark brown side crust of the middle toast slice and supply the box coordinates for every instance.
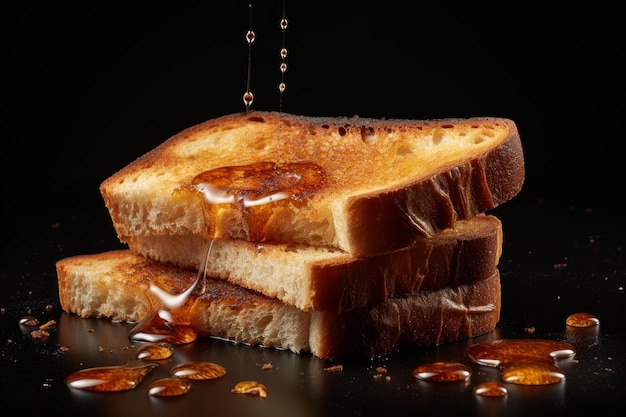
[310,215,502,312]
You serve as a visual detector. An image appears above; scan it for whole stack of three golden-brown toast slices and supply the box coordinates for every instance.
[56,111,525,359]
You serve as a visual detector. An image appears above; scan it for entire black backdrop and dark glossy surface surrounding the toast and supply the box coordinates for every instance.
[0,1,626,417]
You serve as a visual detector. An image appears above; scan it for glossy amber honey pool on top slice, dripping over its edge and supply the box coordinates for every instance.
[192,161,326,241]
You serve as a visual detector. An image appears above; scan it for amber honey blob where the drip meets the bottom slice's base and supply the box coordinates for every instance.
[130,312,198,345]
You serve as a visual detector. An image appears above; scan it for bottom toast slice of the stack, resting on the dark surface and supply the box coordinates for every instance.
[56,250,501,359]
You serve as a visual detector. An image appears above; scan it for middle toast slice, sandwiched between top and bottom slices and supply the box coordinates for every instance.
[124,214,503,311]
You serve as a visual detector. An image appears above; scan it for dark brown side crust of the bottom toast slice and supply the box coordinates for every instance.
[311,270,501,359]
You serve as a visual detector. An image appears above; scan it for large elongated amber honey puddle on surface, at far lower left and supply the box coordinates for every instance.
[65,361,158,392]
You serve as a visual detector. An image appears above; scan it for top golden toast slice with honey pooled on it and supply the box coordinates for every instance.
[100,112,525,256]
